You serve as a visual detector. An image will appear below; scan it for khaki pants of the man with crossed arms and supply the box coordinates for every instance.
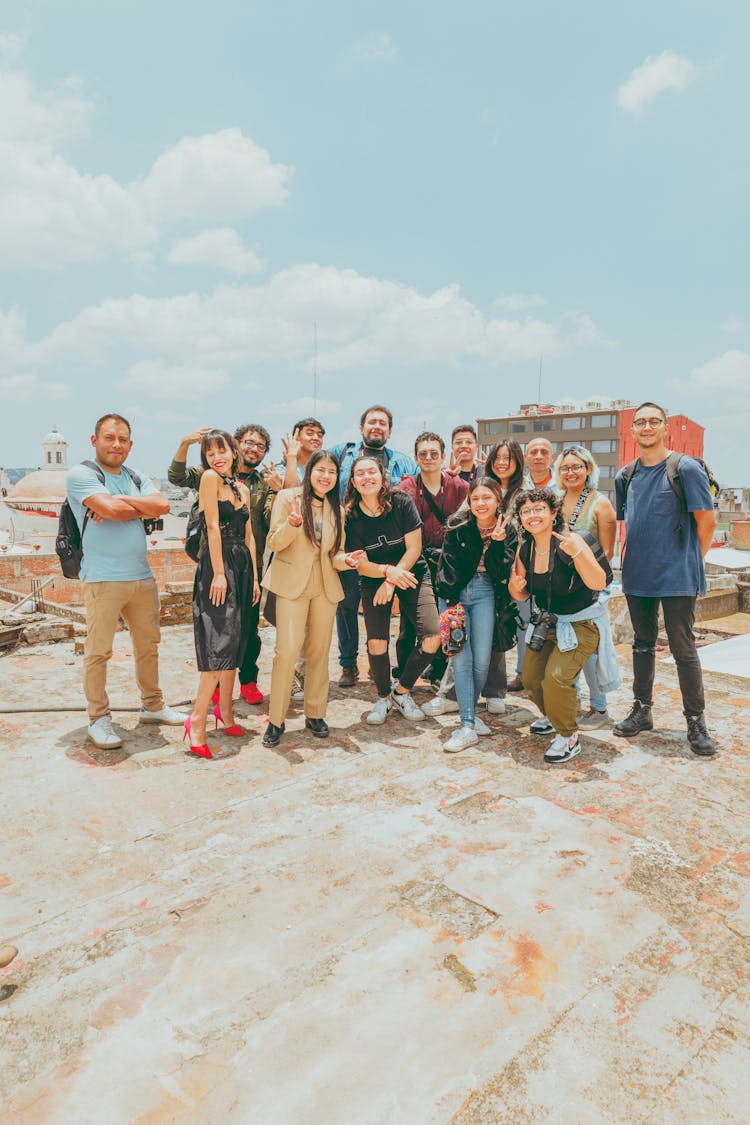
[83,578,164,722]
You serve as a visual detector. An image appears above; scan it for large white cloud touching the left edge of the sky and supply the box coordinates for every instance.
[0,71,292,268]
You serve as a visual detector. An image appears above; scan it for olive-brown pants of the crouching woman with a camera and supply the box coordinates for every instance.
[523,621,599,738]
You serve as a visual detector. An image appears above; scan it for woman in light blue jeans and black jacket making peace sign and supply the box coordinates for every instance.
[436,477,517,754]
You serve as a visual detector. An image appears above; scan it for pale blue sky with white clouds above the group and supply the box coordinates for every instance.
[0,0,750,486]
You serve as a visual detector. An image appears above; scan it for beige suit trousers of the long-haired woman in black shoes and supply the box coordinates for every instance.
[269,559,336,727]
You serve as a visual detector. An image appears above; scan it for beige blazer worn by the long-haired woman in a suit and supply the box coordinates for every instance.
[262,485,349,602]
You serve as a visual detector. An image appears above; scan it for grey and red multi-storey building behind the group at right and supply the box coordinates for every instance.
[477,398,704,503]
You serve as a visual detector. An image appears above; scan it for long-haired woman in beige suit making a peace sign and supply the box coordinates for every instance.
[263,449,347,746]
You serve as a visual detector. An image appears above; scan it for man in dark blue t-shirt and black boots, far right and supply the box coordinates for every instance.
[614,403,716,757]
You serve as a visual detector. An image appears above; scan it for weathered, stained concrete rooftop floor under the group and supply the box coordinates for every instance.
[0,628,750,1125]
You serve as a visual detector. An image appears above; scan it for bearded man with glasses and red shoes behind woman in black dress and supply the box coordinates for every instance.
[166,422,282,703]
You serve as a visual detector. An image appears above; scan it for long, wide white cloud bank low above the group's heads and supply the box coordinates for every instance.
[30,263,607,379]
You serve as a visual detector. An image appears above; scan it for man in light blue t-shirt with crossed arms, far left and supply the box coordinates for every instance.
[66,414,186,750]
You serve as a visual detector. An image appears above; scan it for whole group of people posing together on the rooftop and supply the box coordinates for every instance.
[67,403,715,763]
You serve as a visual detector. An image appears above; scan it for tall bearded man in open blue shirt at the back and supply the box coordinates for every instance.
[331,405,418,687]
